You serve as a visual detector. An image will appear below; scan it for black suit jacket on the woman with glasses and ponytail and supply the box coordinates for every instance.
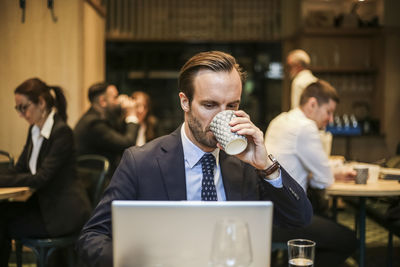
[0,114,90,236]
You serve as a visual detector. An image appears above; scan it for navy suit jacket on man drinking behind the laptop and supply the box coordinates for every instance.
[78,128,312,266]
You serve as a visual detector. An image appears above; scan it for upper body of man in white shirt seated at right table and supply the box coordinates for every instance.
[265,80,355,195]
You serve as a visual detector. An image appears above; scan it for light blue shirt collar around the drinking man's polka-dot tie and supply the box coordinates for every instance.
[181,123,220,168]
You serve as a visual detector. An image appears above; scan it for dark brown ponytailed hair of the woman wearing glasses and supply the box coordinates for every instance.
[14,78,67,121]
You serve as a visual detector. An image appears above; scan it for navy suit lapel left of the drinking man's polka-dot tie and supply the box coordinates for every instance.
[157,127,187,200]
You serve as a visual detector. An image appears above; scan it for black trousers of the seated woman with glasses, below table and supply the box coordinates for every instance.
[0,196,48,267]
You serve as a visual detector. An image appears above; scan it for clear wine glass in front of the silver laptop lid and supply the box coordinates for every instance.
[210,219,253,267]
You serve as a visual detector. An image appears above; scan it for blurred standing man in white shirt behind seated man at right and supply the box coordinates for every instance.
[286,49,318,109]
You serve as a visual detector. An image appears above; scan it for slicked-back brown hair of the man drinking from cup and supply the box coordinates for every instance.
[178,51,246,102]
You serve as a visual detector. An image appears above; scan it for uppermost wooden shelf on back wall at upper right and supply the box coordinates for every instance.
[300,27,381,37]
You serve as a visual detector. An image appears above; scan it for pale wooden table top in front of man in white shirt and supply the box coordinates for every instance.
[326,180,400,197]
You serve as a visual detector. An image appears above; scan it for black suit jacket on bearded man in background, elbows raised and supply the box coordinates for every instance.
[74,107,139,169]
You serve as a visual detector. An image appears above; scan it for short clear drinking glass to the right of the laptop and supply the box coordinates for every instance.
[288,239,315,267]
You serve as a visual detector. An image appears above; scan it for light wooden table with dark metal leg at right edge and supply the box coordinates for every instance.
[326,180,400,267]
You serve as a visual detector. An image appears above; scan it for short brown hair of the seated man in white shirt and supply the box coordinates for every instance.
[300,80,339,106]
